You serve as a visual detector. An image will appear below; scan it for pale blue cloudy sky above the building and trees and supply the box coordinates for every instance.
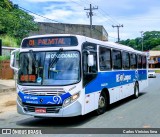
[11,0,160,42]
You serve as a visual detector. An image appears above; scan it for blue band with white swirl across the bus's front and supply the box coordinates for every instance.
[18,91,71,105]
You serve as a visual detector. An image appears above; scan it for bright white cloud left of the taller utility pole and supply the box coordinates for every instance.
[36,3,87,24]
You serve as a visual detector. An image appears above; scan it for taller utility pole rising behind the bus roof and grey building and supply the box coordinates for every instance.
[84,4,98,37]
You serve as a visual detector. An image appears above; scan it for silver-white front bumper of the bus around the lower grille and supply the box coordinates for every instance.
[17,100,82,117]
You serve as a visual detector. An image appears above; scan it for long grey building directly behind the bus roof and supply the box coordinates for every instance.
[29,22,108,41]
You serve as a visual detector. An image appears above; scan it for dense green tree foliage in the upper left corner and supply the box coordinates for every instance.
[0,0,38,44]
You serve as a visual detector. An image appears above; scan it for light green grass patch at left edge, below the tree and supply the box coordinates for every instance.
[0,35,19,47]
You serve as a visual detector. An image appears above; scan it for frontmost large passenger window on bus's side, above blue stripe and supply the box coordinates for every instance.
[99,47,111,71]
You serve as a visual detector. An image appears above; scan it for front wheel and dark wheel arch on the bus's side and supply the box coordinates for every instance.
[96,88,110,115]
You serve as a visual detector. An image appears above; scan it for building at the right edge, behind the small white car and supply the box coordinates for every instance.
[148,50,160,68]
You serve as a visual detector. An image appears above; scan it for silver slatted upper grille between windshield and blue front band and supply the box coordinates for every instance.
[23,88,66,96]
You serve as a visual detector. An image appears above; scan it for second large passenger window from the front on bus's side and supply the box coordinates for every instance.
[112,50,122,69]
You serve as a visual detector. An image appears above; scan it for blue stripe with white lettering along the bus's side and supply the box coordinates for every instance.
[85,70,147,94]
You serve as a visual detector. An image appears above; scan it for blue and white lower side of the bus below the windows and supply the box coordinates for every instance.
[85,70,147,113]
